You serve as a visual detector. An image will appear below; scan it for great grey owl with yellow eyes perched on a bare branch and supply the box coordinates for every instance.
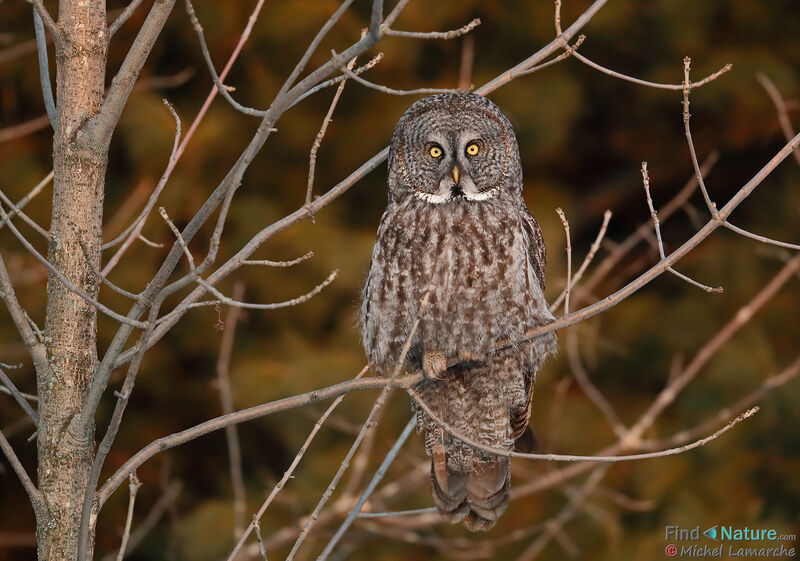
[361,94,556,530]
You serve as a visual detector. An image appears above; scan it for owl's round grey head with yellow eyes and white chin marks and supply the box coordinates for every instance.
[389,94,522,204]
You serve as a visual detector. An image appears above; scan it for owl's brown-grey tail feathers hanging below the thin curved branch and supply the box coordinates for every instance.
[431,443,511,532]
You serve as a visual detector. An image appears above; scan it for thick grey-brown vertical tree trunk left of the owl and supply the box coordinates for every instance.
[37,0,108,561]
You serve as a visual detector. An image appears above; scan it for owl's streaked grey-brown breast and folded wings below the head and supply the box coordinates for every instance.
[361,199,554,371]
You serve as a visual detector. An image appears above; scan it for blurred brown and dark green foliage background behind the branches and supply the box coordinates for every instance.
[0,0,800,561]
